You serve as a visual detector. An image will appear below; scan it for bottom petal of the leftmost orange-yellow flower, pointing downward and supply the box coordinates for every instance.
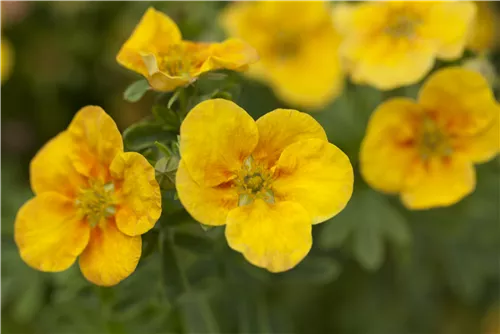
[79,220,142,286]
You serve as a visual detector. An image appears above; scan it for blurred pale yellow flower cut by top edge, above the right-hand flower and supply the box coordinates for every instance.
[334,0,475,90]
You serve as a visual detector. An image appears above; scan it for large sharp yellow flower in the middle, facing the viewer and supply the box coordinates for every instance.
[176,99,353,272]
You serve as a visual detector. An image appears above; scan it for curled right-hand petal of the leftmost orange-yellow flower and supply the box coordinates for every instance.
[110,152,161,236]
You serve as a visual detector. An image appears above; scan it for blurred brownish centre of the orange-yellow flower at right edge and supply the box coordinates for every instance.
[419,118,453,159]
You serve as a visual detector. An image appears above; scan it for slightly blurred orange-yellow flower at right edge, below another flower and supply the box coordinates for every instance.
[360,67,500,209]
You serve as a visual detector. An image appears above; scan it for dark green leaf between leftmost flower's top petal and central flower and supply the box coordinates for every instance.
[123,121,177,152]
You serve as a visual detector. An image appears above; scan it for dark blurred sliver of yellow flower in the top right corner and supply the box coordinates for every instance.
[468,0,500,53]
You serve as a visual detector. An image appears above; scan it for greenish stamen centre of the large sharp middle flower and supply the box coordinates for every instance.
[234,157,274,206]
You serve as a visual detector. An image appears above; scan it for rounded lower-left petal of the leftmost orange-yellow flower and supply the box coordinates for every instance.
[14,192,90,271]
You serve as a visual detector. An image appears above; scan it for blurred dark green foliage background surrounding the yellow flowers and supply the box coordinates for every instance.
[0,0,500,334]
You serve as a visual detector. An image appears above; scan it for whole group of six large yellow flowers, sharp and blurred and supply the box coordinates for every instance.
[15,1,500,286]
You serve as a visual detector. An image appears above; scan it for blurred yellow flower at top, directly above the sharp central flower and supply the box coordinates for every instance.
[221,1,344,109]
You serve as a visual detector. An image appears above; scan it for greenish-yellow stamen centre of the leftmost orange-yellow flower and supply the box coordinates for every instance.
[75,181,116,226]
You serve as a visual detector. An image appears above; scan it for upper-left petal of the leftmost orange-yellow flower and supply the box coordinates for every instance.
[30,131,85,198]
